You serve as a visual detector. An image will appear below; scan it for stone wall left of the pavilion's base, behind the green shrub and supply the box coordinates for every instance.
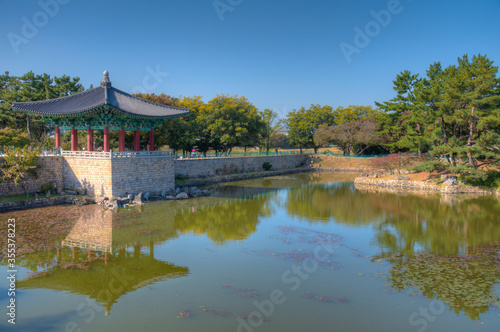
[0,156,63,196]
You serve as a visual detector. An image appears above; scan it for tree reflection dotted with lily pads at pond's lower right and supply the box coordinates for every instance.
[375,242,500,319]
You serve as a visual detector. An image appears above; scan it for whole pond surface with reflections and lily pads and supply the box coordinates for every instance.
[0,173,500,332]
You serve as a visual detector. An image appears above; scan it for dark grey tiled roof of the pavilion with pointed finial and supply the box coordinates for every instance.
[12,71,189,118]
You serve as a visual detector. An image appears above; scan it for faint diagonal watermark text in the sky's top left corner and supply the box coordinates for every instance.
[7,0,70,54]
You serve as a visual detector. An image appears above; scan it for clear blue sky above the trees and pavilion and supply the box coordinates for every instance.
[0,0,500,115]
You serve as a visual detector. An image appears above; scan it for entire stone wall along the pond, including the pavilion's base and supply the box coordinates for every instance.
[0,155,309,197]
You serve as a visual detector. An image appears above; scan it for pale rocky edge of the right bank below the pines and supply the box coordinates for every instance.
[354,176,500,196]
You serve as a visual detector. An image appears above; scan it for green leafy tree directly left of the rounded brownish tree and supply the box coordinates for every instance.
[286,105,335,152]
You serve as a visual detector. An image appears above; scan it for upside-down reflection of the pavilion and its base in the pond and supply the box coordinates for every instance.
[17,208,189,315]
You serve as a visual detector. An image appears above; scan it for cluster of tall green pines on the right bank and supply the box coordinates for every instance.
[377,54,500,177]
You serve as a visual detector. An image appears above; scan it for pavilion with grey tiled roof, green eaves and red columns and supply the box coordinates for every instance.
[12,70,189,152]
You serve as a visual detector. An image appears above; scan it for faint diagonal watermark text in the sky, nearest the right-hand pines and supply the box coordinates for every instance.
[339,0,411,63]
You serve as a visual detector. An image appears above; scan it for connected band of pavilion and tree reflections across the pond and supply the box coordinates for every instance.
[3,173,500,319]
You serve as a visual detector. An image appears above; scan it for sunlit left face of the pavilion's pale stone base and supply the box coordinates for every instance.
[63,156,112,196]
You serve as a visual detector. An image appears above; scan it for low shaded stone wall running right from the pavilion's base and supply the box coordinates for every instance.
[174,154,309,178]
